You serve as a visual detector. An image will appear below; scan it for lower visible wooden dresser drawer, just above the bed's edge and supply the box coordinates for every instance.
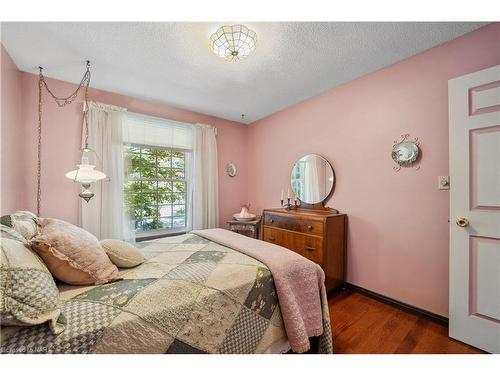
[262,227,323,265]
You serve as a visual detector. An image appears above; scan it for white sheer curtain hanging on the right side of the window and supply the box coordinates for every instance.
[189,124,219,229]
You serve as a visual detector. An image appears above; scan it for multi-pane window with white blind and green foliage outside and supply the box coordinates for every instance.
[124,113,192,236]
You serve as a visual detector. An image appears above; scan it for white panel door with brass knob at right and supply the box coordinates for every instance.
[448,65,500,353]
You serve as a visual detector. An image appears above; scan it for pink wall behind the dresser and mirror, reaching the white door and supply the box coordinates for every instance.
[248,23,500,316]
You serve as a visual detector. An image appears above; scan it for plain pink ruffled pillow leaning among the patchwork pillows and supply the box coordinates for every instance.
[31,219,120,285]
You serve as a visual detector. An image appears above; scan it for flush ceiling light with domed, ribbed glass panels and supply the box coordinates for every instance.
[210,25,257,61]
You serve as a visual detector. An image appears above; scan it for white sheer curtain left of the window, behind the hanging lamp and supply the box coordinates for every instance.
[80,103,135,242]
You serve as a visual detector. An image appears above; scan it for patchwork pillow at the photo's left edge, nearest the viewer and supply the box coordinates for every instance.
[0,238,65,334]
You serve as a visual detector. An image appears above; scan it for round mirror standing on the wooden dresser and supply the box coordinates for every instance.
[291,154,335,204]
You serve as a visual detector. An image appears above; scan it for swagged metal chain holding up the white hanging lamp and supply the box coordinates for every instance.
[36,60,90,216]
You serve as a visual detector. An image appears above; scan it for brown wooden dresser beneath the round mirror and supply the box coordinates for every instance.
[262,208,346,291]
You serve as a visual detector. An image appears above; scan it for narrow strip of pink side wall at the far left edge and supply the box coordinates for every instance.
[0,46,24,215]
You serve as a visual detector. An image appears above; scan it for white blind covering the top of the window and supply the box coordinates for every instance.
[123,112,193,151]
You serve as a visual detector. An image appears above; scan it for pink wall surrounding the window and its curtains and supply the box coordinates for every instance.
[15,73,247,227]
